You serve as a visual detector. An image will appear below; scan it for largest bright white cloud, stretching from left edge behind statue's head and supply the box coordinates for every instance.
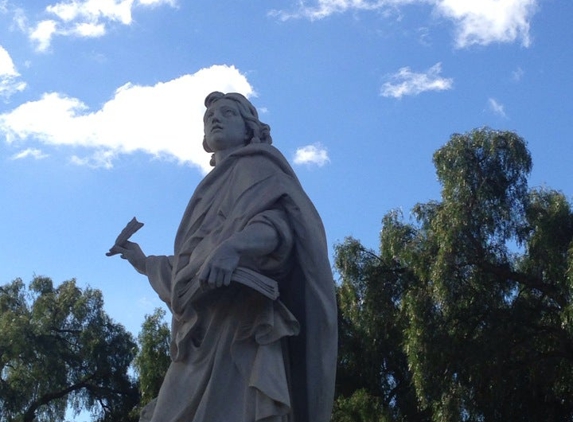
[0,66,254,172]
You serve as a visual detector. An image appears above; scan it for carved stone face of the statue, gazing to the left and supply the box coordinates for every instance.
[203,98,248,152]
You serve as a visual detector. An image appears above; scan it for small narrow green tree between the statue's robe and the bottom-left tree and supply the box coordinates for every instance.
[134,308,171,407]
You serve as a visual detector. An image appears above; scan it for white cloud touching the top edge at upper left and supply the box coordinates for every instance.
[19,0,176,51]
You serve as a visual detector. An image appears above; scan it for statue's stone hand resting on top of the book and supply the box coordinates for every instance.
[199,242,240,289]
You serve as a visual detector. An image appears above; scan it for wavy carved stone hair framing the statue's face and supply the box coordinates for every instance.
[203,91,273,157]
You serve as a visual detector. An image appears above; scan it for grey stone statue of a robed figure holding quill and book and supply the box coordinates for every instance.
[110,92,337,422]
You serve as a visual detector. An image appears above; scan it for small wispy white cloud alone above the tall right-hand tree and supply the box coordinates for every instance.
[380,63,454,98]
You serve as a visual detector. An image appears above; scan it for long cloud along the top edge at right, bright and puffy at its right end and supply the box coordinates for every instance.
[269,0,539,48]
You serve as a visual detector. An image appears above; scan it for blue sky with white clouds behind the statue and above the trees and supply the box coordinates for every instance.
[0,0,573,334]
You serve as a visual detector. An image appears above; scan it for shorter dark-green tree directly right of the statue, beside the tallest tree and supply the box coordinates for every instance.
[333,238,425,422]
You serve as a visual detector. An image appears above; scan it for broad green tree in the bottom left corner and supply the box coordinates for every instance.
[0,277,138,422]
